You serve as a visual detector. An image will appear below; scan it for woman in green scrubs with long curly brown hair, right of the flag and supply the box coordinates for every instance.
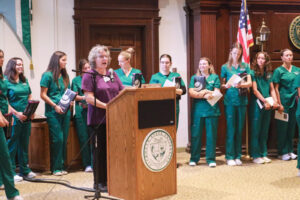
[249,52,279,164]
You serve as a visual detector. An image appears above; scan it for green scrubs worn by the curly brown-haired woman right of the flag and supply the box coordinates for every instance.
[249,71,272,159]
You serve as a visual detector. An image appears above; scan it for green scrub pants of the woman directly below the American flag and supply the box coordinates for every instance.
[225,105,247,160]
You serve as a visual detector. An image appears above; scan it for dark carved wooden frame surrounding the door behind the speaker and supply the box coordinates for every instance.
[73,0,160,81]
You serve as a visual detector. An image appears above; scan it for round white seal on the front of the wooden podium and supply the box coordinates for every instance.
[142,129,174,172]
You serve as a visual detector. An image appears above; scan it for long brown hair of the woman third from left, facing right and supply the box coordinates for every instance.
[46,51,70,88]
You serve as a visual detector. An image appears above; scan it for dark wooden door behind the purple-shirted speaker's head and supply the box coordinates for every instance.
[89,25,144,71]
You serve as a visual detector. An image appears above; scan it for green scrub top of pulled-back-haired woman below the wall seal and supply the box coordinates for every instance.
[272,65,300,108]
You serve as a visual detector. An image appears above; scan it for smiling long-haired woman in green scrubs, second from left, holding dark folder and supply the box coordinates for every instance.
[4,58,36,180]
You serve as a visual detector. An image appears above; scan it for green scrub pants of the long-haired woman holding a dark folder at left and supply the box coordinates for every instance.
[7,117,31,175]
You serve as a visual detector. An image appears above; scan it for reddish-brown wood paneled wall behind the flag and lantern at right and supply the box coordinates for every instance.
[184,0,300,146]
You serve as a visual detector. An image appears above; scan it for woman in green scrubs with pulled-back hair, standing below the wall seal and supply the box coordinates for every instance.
[272,49,300,161]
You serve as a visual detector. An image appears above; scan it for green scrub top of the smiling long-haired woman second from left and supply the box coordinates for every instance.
[6,79,31,112]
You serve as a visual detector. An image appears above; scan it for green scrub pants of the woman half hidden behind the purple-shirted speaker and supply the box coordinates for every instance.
[74,105,92,167]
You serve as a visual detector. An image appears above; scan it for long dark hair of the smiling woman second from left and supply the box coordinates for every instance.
[4,57,26,83]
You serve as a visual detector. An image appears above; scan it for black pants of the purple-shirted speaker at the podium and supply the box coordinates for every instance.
[90,124,107,186]
